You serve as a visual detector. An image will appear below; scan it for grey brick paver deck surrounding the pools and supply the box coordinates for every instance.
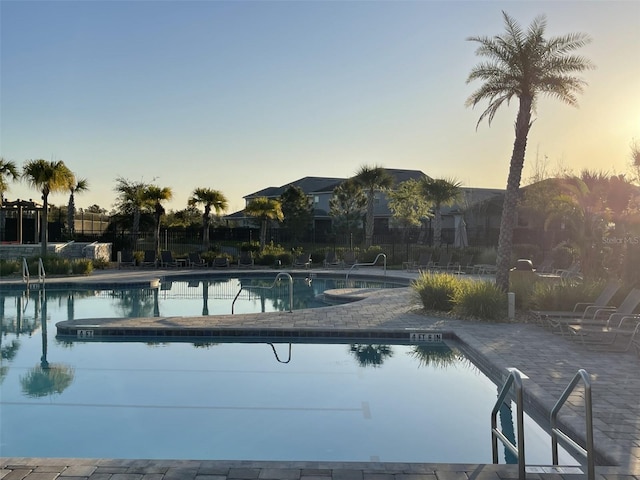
[0,269,640,480]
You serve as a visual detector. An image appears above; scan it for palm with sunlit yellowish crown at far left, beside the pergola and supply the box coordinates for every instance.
[22,159,73,257]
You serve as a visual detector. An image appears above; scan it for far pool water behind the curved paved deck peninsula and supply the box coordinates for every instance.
[0,275,406,321]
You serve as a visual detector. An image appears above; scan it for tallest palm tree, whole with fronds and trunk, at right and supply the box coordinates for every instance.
[466,12,593,291]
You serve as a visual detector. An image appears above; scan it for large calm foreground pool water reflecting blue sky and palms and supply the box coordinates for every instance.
[0,309,575,464]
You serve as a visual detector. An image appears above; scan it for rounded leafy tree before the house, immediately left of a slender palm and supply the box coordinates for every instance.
[329,178,367,240]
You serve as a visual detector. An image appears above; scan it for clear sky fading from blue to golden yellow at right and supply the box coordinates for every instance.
[0,0,640,213]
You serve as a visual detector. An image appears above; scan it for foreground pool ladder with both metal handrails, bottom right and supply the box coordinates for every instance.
[491,368,595,480]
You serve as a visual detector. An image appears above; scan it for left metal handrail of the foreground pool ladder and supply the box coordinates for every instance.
[491,369,526,480]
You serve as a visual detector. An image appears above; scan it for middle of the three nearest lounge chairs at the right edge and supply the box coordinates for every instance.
[546,288,640,338]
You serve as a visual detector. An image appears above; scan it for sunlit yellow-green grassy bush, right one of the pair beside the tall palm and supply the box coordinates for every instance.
[453,280,507,321]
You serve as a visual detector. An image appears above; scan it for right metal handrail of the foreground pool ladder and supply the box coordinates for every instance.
[551,368,595,480]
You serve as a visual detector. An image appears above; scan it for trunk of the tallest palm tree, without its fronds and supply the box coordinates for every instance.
[496,96,532,292]
